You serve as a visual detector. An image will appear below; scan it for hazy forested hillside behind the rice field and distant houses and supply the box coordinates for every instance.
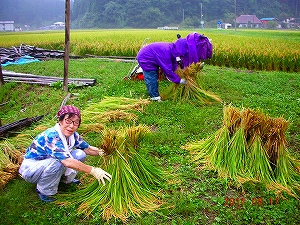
[0,0,300,29]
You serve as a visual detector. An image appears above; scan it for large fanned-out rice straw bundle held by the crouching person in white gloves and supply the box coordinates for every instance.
[57,126,163,222]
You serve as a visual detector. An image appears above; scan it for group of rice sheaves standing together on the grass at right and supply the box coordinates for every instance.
[183,106,300,196]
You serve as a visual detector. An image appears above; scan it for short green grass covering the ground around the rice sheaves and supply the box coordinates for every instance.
[0,59,300,225]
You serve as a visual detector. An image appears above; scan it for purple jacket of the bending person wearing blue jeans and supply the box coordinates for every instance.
[137,38,188,83]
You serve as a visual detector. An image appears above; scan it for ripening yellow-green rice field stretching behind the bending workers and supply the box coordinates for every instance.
[0,29,300,72]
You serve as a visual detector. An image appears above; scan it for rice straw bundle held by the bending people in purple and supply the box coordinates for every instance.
[161,62,221,104]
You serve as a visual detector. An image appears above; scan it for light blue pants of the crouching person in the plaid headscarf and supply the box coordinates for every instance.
[19,149,86,195]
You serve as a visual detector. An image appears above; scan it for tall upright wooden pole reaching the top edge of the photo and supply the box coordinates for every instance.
[63,0,70,92]
